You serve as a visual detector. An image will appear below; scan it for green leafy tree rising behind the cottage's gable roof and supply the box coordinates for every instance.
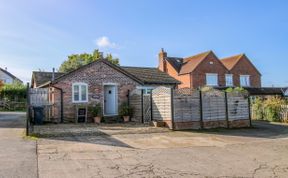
[59,49,119,72]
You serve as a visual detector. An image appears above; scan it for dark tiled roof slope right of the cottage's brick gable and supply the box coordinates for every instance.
[120,66,180,84]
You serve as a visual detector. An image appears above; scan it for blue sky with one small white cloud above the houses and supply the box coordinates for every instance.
[0,0,288,87]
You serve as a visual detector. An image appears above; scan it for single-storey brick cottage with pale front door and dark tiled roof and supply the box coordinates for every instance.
[31,59,180,122]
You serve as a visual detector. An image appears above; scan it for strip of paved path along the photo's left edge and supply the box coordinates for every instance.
[0,112,37,178]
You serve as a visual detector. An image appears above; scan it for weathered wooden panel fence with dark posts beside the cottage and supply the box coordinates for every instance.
[130,87,251,130]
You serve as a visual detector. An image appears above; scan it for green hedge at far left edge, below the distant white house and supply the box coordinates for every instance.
[0,82,26,101]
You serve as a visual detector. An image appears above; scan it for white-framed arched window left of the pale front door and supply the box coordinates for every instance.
[72,83,88,103]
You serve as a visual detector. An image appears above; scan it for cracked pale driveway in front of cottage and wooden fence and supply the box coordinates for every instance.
[38,122,288,178]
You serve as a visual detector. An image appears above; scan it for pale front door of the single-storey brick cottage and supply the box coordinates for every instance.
[104,85,117,116]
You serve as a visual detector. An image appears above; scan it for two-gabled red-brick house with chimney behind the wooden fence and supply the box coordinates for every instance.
[158,49,261,88]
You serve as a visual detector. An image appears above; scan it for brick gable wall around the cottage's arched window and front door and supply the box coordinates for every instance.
[54,62,139,121]
